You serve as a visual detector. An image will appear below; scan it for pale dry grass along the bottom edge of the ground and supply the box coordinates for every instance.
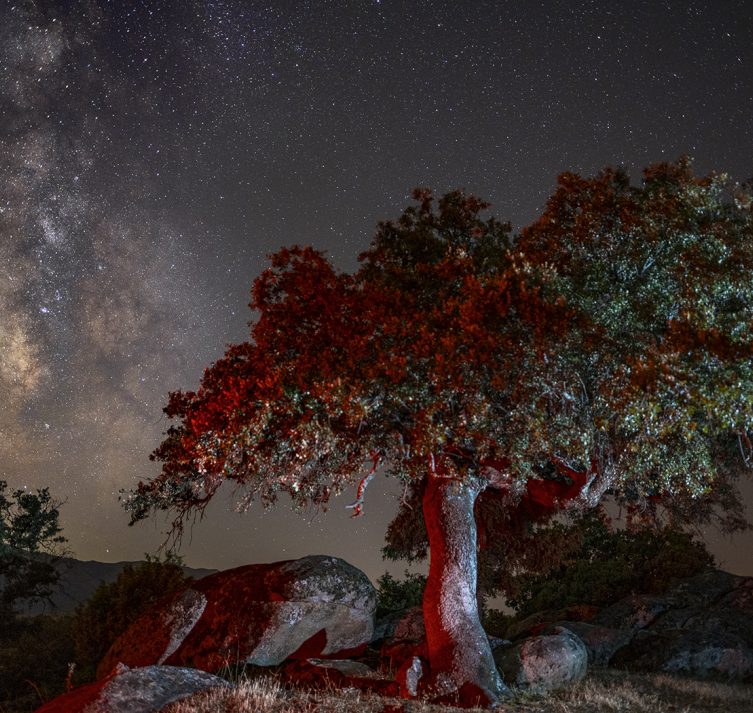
[165,670,753,713]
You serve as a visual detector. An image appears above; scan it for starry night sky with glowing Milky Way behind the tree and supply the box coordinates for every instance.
[0,0,753,578]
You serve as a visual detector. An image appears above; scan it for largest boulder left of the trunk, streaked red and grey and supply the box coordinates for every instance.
[97,555,376,677]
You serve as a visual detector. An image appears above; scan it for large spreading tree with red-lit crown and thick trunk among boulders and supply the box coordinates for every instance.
[126,162,753,703]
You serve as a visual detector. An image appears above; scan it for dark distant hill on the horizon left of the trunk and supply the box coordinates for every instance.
[17,557,217,615]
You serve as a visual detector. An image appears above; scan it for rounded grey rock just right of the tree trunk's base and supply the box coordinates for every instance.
[494,629,588,692]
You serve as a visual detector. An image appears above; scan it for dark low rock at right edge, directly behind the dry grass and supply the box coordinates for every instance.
[611,629,753,681]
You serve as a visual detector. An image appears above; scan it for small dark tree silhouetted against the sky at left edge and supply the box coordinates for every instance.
[0,480,66,625]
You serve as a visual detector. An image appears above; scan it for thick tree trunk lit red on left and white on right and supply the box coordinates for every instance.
[423,473,509,705]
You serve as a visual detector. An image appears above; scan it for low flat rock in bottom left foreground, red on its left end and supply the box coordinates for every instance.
[36,665,230,713]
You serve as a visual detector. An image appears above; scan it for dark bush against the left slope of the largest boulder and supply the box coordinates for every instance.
[74,554,190,680]
